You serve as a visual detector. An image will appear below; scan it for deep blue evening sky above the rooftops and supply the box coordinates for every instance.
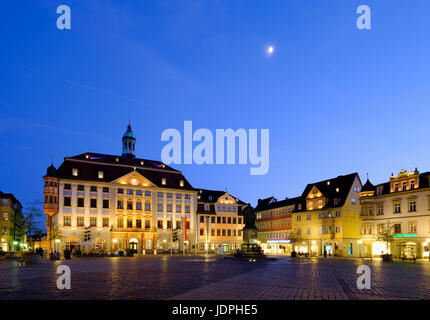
[0,0,430,218]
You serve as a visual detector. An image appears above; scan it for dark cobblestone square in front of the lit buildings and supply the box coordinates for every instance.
[0,255,430,300]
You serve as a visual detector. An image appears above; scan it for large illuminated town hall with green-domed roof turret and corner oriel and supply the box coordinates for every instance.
[44,124,198,254]
